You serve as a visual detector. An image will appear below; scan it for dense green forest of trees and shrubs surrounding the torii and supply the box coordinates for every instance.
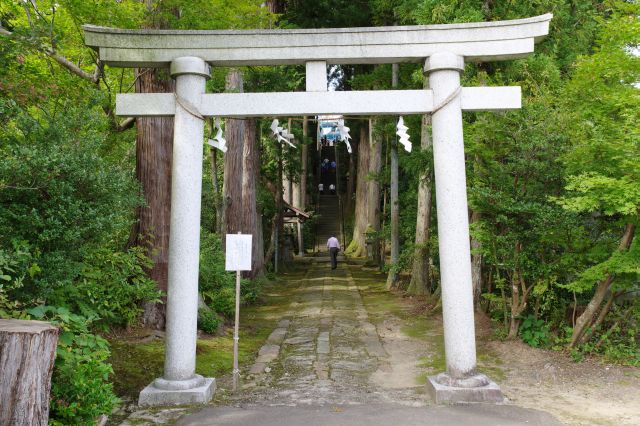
[0,0,640,424]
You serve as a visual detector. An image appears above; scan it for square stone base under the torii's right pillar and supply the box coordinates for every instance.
[427,373,504,404]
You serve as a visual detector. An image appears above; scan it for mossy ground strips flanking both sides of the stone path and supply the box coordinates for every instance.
[111,262,504,402]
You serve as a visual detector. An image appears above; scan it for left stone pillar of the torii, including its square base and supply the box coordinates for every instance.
[138,57,216,406]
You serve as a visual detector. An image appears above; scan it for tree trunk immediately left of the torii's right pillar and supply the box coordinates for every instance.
[407,110,433,295]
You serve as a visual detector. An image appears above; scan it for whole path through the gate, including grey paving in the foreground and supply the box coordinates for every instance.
[117,258,560,426]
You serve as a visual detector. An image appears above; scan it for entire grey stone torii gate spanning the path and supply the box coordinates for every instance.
[83,14,552,405]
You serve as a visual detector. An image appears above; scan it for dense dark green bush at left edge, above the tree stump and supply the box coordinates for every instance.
[0,101,140,300]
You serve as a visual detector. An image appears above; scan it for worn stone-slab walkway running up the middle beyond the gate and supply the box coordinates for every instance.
[243,262,417,405]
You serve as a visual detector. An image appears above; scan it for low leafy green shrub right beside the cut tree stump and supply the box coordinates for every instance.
[28,306,119,425]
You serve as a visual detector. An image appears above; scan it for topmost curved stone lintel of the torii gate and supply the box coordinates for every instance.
[83,14,552,67]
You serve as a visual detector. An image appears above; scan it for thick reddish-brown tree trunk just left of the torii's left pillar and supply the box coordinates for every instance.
[133,69,175,330]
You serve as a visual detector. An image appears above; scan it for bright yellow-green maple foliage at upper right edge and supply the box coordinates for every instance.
[561,2,640,216]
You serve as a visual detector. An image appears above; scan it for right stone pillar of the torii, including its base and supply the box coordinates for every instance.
[424,52,504,403]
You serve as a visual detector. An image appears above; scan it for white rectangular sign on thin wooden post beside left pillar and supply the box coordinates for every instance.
[225,232,252,392]
